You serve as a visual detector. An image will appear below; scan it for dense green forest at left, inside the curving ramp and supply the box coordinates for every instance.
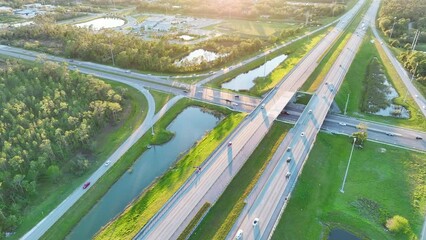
[0,62,122,236]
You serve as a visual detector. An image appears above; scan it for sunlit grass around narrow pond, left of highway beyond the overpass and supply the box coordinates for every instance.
[207,29,329,96]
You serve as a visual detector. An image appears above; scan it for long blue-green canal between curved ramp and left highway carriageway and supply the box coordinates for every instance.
[67,107,219,240]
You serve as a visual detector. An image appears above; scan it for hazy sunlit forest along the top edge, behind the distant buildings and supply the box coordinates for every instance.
[137,0,346,21]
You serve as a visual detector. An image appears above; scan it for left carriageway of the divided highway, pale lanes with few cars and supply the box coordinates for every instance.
[135,1,364,239]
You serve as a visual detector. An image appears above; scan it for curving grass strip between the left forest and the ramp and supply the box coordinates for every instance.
[10,82,148,239]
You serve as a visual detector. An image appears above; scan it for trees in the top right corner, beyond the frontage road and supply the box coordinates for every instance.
[377,0,426,86]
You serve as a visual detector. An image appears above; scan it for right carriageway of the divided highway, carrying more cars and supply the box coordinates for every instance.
[227,0,380,239]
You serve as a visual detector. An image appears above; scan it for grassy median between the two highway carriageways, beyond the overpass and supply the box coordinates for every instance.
[300,1,371,92]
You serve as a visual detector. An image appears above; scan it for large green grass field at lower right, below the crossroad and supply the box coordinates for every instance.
[272,133,426,240]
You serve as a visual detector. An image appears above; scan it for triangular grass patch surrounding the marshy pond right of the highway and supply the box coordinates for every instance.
[335,31,426,131]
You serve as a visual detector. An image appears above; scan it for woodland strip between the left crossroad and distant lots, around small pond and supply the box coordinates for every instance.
[0,17,262,72]
